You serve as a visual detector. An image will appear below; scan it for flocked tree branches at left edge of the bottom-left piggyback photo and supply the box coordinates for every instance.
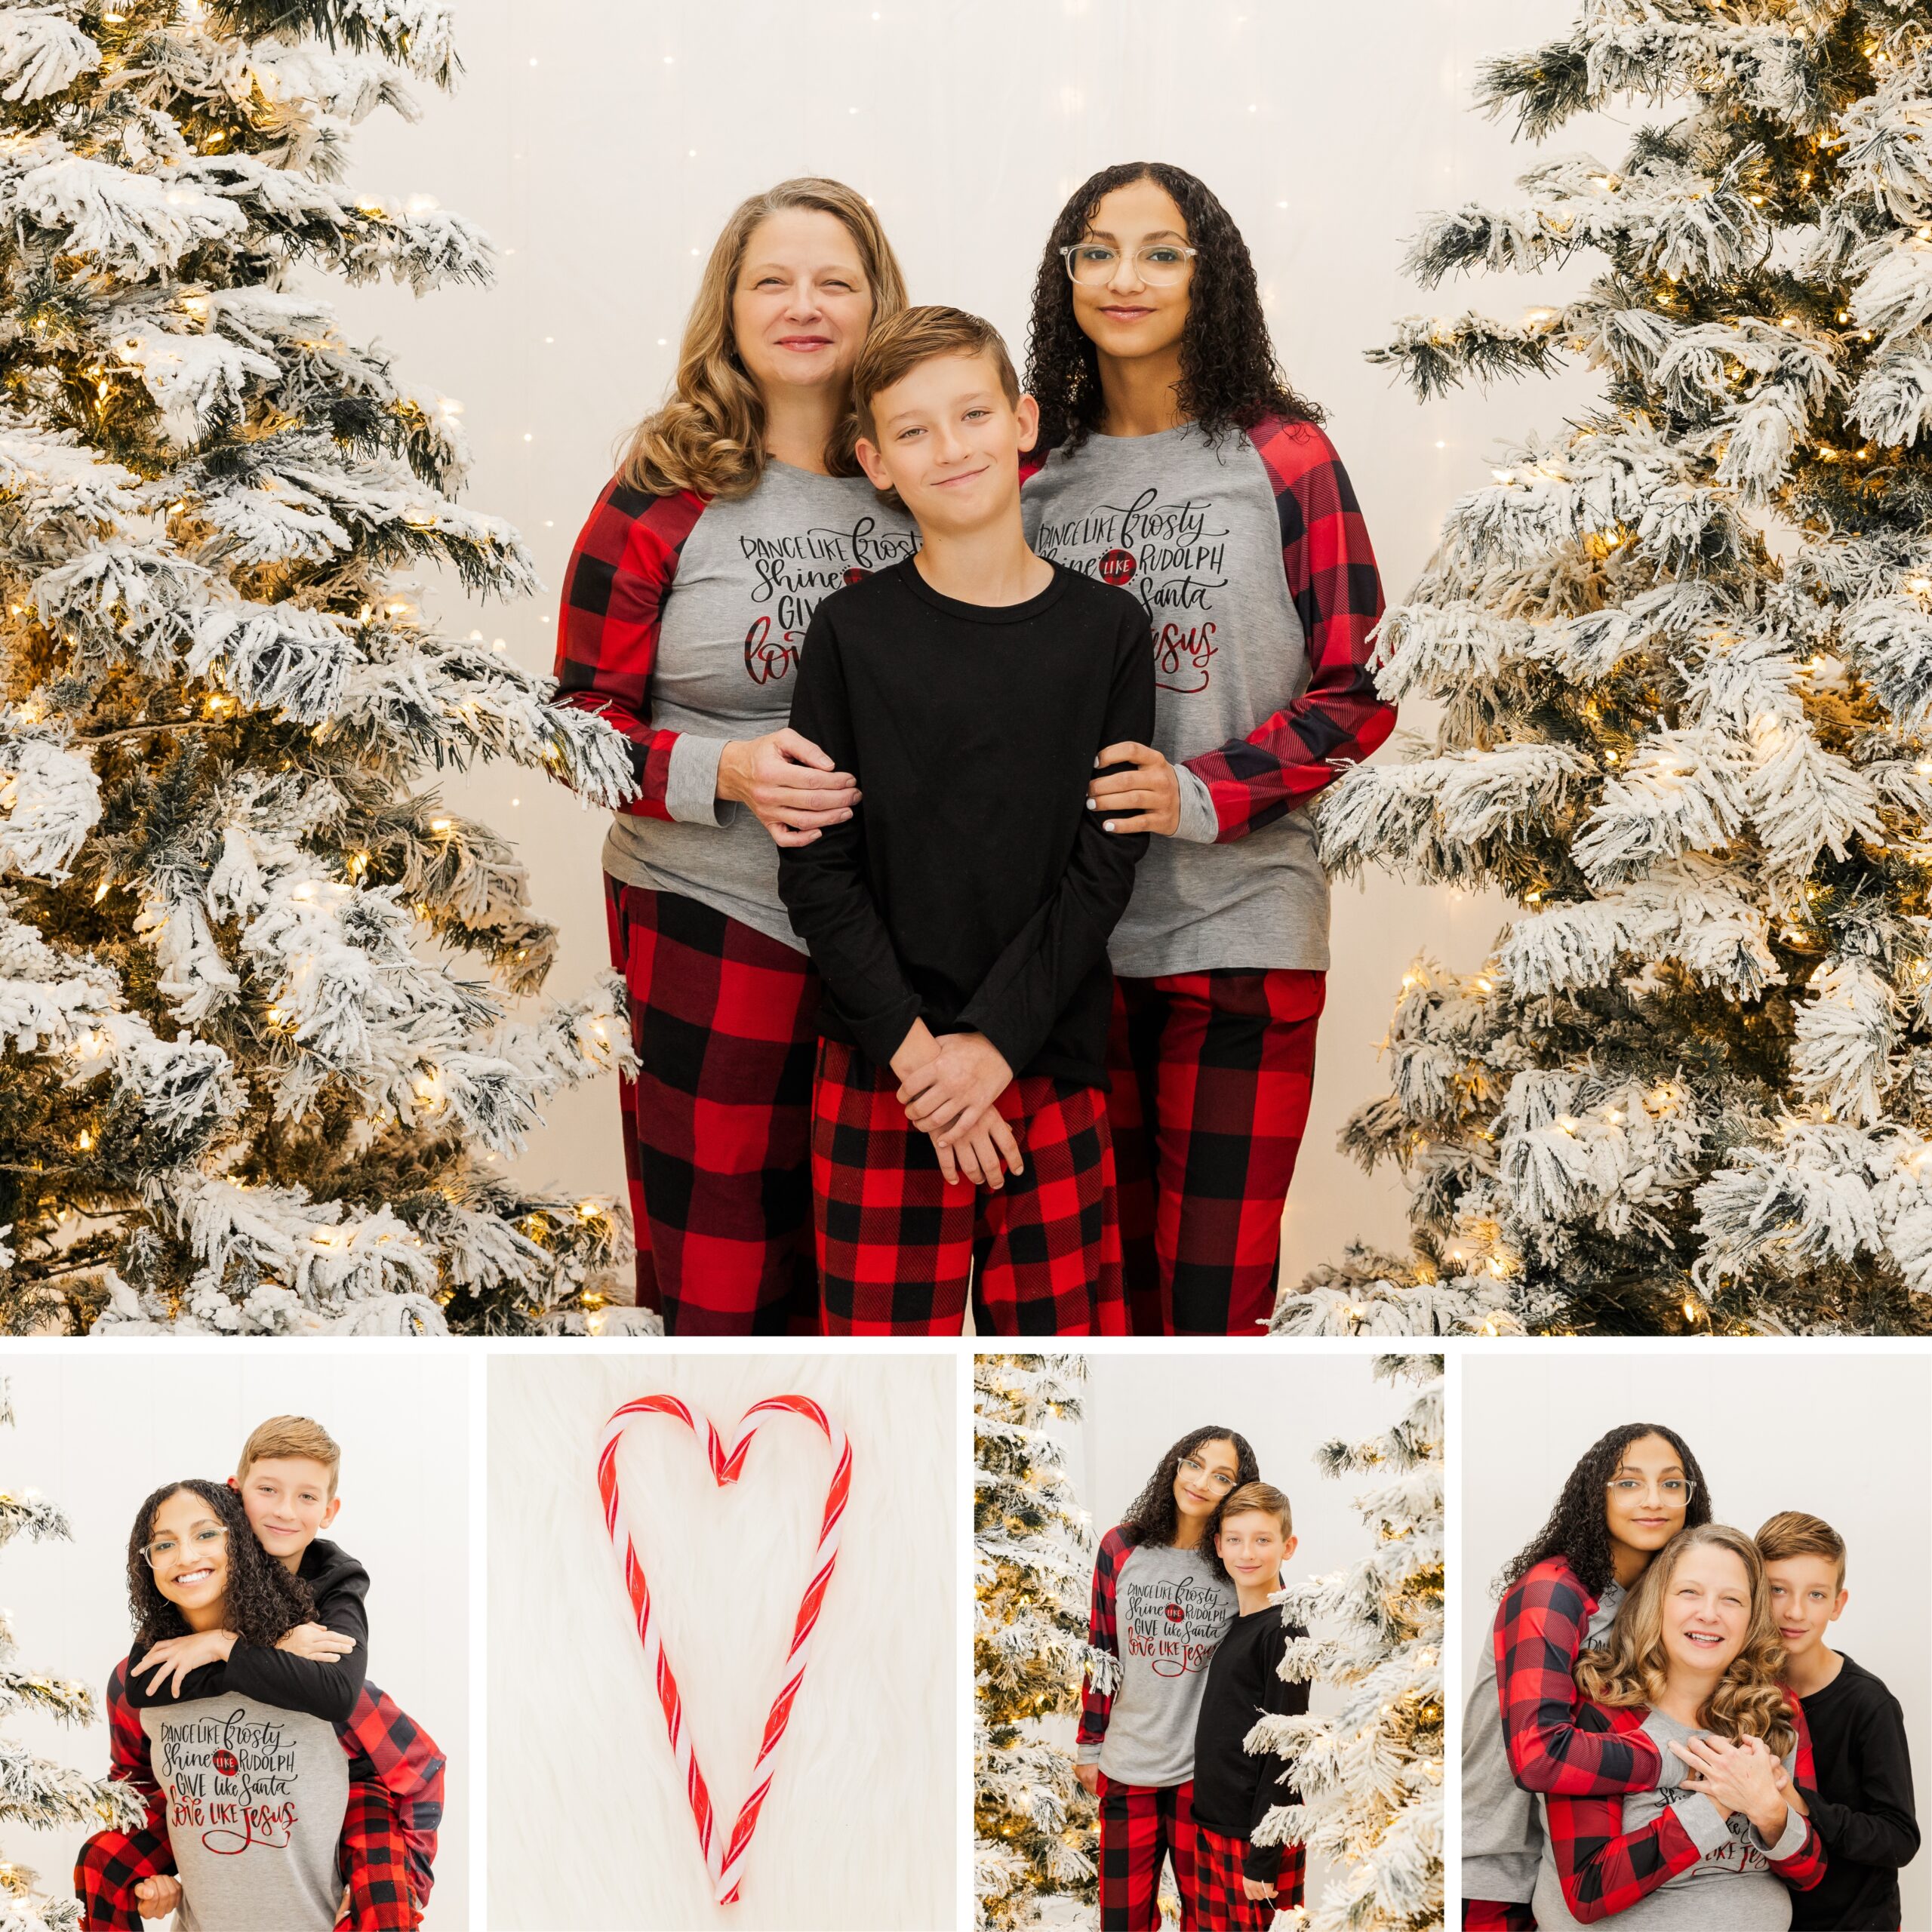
[0,1380,147,1932]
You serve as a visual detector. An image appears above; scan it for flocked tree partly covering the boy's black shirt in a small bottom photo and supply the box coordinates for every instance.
[1248,1355,1443,1932]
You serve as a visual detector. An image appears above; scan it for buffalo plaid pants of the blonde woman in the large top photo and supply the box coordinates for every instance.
[605,877,819,1335]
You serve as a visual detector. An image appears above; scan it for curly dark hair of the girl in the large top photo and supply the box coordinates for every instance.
[1026,160,1321,450]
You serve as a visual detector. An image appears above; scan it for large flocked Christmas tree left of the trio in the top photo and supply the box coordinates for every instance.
[0,0,630,1333]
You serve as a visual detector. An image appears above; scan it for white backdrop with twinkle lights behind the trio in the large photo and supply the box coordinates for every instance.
[309,0,1625,1306]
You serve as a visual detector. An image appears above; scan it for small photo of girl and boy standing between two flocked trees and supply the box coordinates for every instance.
[974,1350,1445,1932]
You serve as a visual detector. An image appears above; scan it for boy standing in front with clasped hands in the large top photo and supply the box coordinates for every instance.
[779,307,1153,1335]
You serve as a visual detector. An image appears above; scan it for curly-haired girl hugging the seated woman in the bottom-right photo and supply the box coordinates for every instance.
[1463,1422,1710,1932]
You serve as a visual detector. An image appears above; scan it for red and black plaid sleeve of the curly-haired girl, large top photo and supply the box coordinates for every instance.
[1186,417,1395,844]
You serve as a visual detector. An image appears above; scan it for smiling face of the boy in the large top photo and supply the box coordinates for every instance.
[858,355,1039,535]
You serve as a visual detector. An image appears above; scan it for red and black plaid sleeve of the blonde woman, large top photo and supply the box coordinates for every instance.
[556,477,705,819]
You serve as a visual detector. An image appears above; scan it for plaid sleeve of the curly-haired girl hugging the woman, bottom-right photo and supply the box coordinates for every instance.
[1495,1557,1663,1797]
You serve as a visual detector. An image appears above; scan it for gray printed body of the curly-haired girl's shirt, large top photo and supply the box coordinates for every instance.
[1020,423,1329,977]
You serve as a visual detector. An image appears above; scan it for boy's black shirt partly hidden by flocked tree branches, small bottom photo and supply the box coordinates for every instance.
[1194,1604,1308,1884]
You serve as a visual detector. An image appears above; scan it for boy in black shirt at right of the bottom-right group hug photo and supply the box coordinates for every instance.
[1756,1509,1918,1932]
